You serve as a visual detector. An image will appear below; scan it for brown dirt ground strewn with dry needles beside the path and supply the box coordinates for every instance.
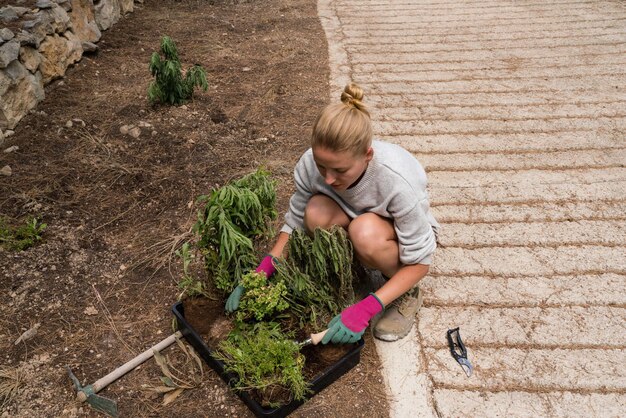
[0,0,388,417]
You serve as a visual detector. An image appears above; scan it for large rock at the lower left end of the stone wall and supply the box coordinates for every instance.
[0,60,45,129]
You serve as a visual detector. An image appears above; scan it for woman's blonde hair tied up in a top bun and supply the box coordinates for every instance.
[311,83,372,155]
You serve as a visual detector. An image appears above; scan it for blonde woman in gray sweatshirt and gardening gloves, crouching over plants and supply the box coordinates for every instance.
[226,84,439,344]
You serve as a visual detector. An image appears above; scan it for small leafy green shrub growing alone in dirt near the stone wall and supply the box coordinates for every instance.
[148,36,209,105]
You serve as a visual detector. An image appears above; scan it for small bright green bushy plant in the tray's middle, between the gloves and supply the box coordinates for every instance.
[236,272,289,321]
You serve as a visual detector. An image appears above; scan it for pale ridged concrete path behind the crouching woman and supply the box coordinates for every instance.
[318,0,626,417]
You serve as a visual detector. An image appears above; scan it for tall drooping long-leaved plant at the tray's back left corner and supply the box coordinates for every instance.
[193,169,277,292]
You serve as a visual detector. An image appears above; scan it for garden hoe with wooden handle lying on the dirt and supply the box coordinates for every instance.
[65,331,182,417]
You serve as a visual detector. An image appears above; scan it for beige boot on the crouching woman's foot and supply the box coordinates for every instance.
[374,286,424,341]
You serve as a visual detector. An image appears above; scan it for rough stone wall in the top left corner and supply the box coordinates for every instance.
[0,0,143,141]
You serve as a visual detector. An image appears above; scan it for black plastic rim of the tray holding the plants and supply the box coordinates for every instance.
[172,302,365,417]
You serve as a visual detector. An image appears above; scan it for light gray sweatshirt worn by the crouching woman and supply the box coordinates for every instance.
[281,141,439,265]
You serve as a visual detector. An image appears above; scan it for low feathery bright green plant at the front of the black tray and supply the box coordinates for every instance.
[213,322,309,407]
